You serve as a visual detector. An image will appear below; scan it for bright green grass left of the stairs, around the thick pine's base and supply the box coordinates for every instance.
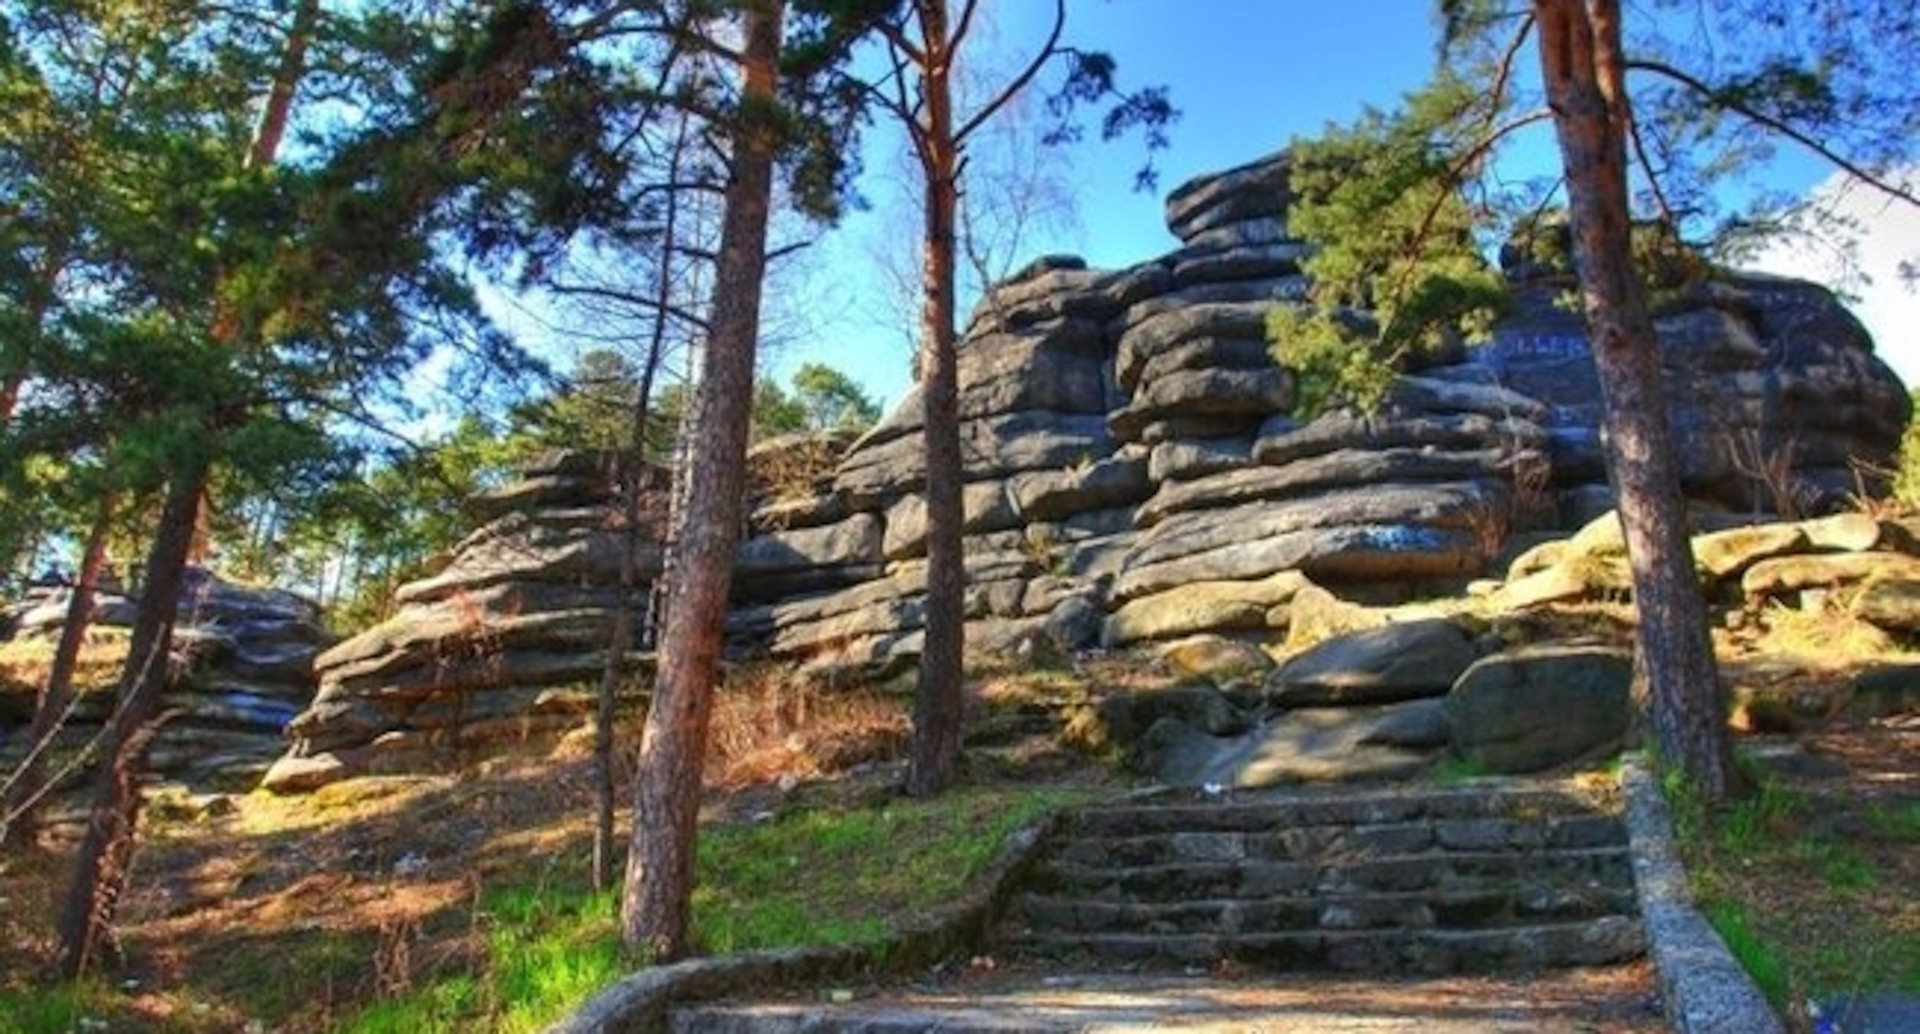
[346,790,1073,1034]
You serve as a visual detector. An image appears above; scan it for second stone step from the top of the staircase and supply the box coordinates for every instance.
[1054,815,1626,867]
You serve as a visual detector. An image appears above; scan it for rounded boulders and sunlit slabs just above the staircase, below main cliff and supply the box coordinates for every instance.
[1105,512,1920,787]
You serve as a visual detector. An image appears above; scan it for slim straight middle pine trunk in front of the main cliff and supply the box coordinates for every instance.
[906,0,966,796]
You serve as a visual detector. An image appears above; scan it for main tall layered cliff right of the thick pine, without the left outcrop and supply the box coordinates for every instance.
[733,145,1908,675]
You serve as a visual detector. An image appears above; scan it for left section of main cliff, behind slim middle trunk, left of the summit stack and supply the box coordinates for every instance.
[730,259,1152,675]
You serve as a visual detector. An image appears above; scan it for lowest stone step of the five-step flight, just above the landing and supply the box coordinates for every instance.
[998,915,1645,975]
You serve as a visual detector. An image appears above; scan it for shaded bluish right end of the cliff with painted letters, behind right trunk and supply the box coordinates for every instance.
[1427,251,1912,528]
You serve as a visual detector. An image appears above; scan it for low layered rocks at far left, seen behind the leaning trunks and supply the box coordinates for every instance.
[0,568,332,785]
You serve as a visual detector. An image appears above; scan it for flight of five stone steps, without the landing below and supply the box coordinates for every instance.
[993,781,1644,975]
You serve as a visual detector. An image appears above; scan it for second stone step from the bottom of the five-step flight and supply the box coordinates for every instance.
[1008,884,1636,934]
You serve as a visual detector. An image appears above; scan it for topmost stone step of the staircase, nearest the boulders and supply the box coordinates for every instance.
[1064,783,1617,836]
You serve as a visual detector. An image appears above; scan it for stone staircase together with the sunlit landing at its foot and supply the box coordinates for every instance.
[668,781,1665,1034]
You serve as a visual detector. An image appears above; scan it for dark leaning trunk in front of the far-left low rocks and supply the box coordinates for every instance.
[58,457,207,980]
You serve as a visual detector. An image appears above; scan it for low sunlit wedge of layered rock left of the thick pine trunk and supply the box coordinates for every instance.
[265,451,660,790]
